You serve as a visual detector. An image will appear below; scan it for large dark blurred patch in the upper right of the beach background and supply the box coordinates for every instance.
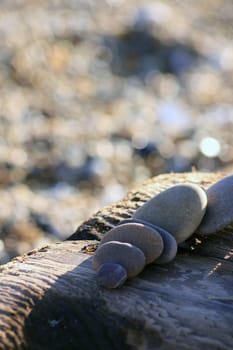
[102,29,202,80]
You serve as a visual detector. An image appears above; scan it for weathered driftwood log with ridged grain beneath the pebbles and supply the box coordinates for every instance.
[0,173,233,350]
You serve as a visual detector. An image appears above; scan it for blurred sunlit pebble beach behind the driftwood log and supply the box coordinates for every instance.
[0,0,233,263]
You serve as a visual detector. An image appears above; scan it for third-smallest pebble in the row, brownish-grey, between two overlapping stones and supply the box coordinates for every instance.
[101,222,164,264]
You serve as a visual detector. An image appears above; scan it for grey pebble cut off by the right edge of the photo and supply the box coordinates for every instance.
[197,175,233,235]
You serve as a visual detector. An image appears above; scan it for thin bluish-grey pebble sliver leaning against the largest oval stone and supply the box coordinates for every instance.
[118,219,177,264]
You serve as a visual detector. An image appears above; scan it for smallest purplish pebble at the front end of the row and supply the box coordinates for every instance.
[97,263,127,288]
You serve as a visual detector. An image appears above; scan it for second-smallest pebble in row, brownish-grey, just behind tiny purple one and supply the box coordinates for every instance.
[92,241,146,278]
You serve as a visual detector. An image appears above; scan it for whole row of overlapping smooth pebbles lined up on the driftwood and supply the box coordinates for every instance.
[93,175,233,288]
